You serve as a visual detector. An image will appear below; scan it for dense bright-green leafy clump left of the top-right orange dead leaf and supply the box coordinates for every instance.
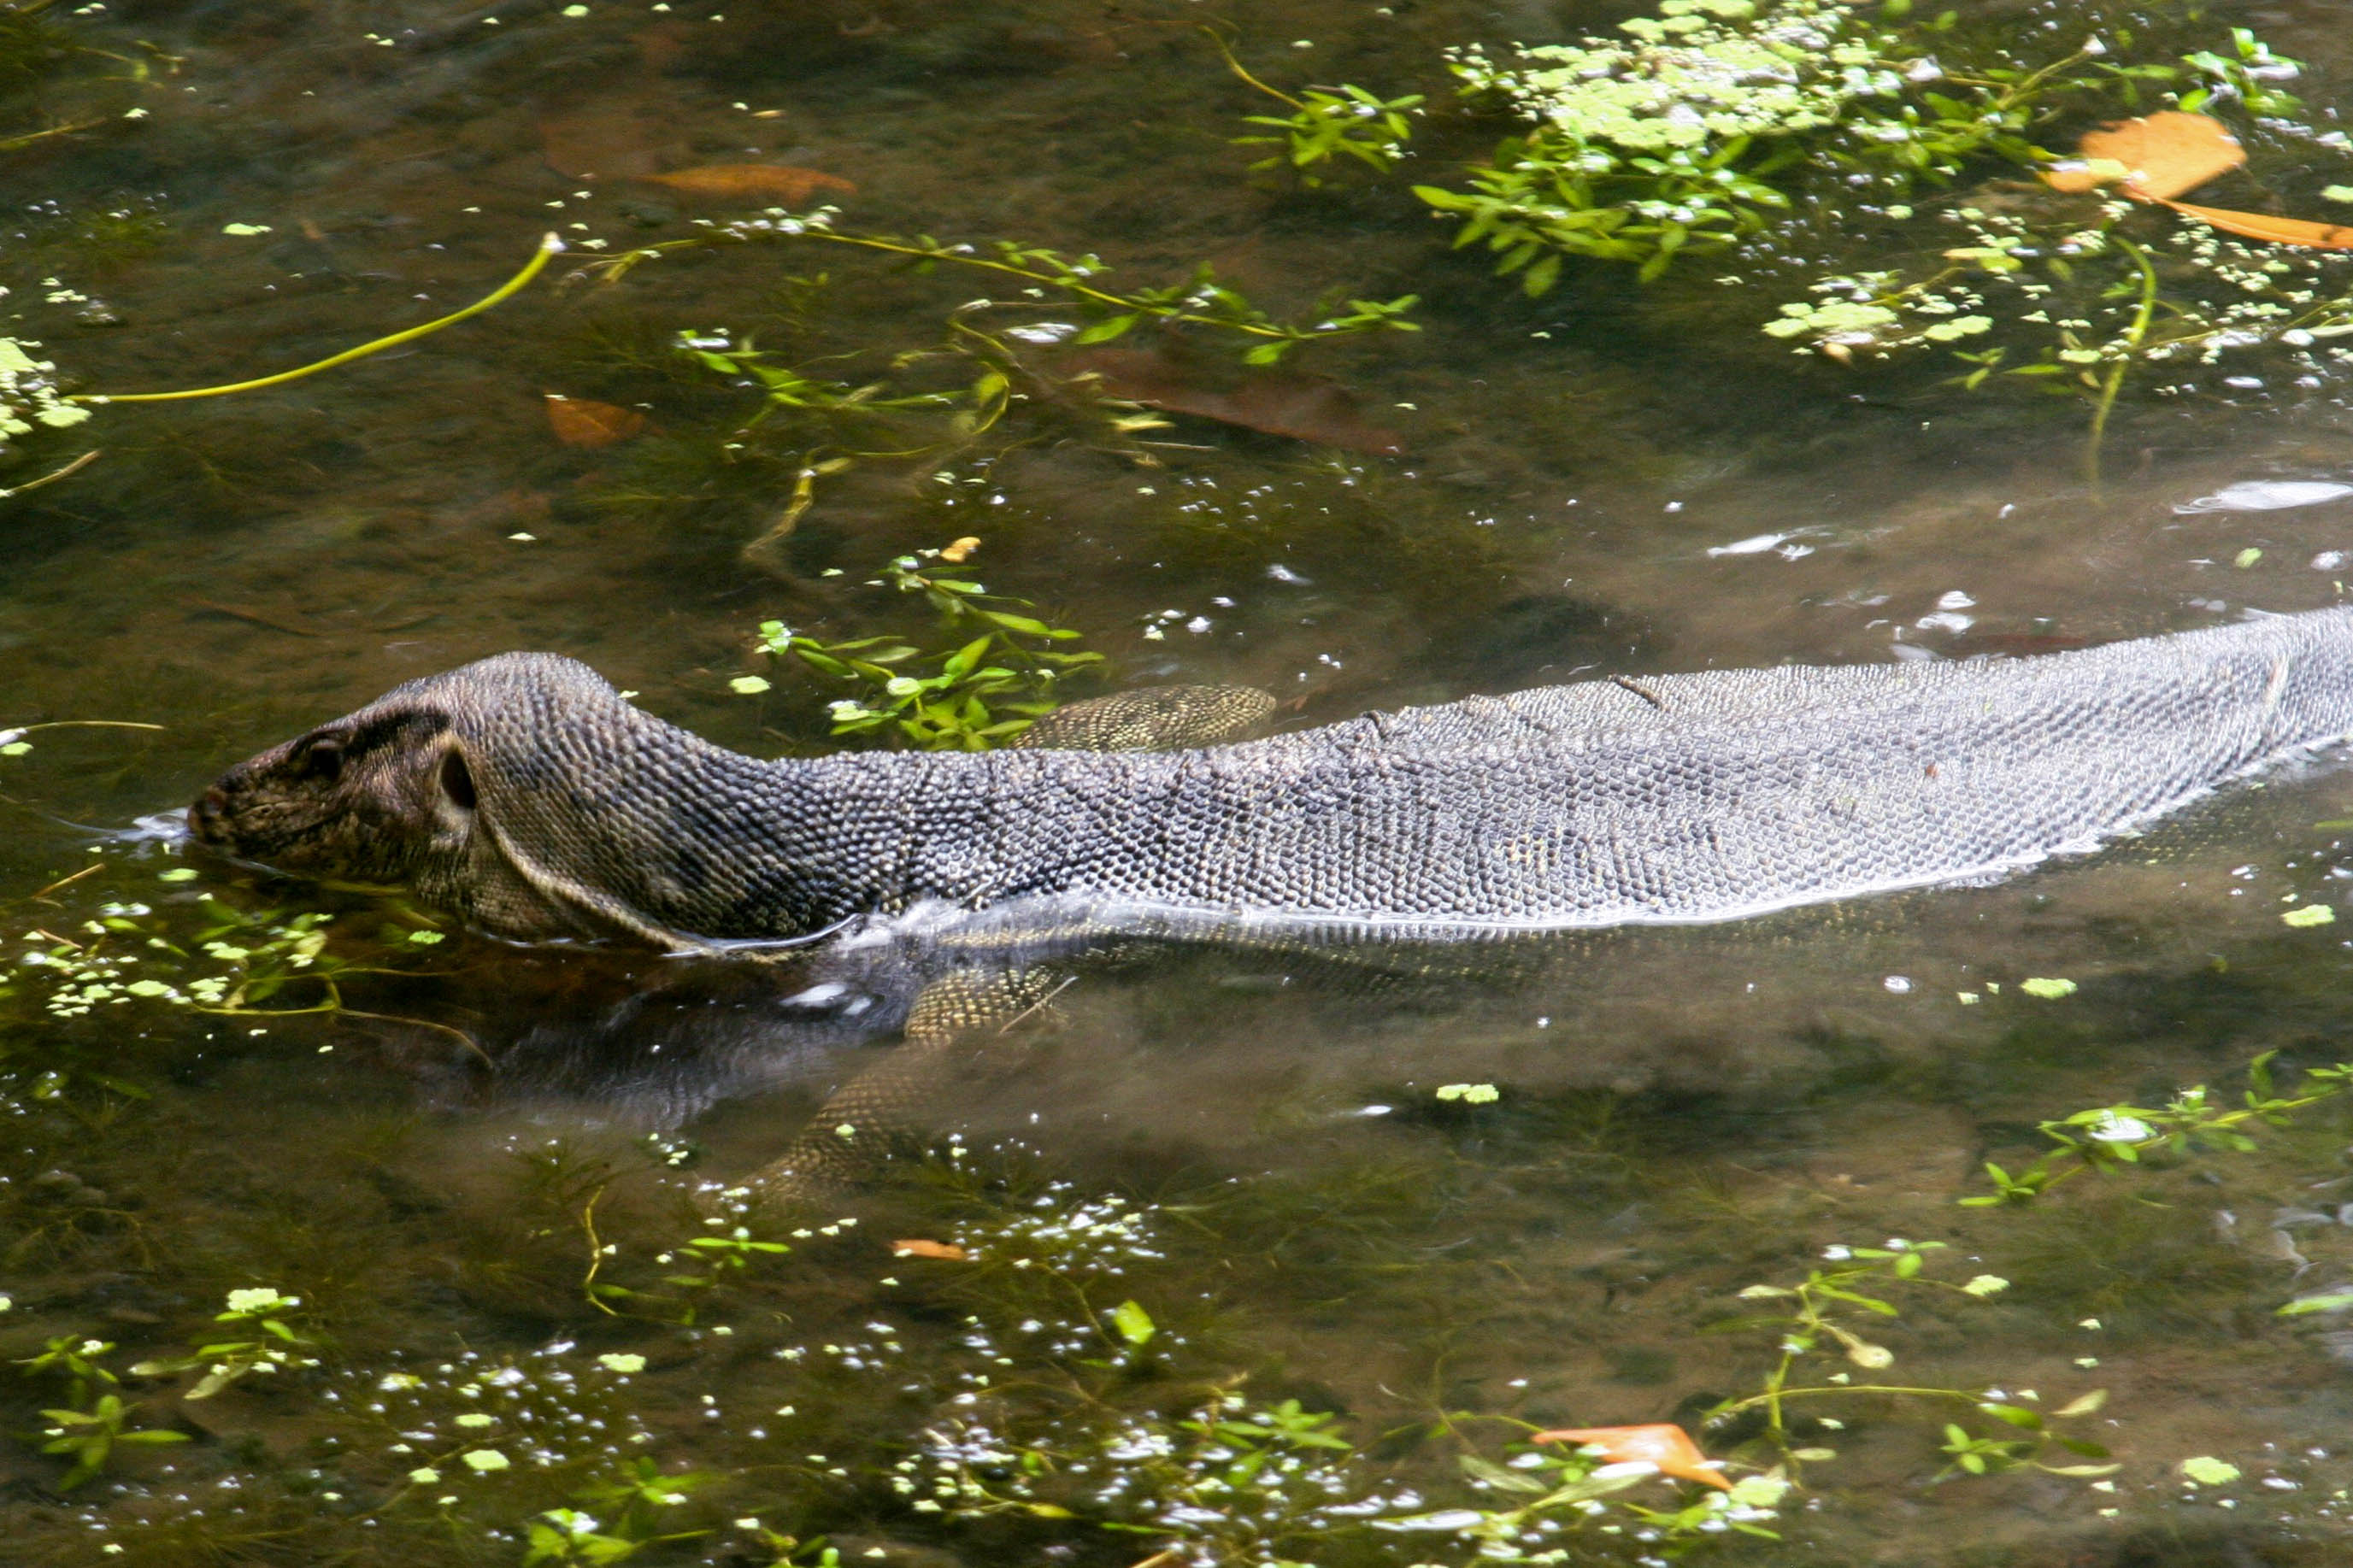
[1415,0,2297,294]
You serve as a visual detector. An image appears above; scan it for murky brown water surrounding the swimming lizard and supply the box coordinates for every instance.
[0,0,2353,1568]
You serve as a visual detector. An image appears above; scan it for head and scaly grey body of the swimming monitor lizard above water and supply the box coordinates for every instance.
[191,609,2353,949]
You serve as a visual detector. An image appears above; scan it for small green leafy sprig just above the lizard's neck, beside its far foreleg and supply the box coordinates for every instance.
[734,538,1103,752]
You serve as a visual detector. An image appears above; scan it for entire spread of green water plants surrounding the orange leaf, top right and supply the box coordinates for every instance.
[1219,0,2353,477]
